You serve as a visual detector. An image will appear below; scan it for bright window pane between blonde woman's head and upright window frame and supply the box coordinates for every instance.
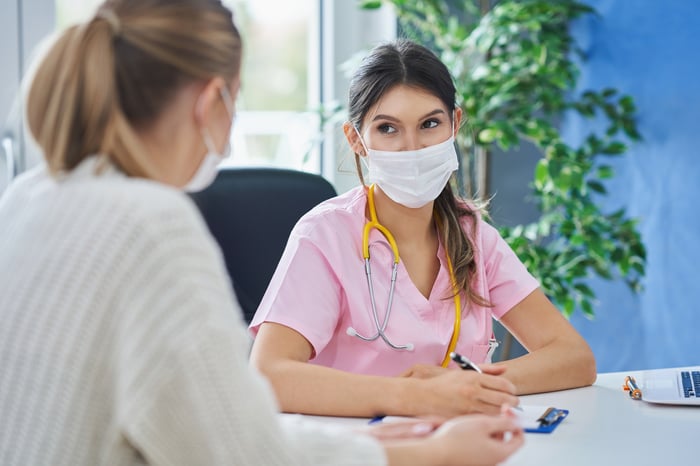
[225,0,321,172]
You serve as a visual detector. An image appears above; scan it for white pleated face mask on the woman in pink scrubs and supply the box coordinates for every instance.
[355,129,459,209]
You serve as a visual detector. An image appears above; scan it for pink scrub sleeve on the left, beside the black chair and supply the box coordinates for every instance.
[250,233,343,355]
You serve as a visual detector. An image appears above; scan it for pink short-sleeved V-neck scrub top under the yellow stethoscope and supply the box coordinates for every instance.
[250,186,539,376]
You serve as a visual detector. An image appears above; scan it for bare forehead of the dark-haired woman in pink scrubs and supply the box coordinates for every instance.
[365,84,447,121]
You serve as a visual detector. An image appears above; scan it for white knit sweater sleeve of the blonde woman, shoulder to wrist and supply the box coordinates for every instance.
[116,197,386,465]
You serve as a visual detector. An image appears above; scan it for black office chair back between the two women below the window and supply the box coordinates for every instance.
[192,167,336,322]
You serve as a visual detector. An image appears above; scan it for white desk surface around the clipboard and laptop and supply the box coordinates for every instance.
[286,371,700,466]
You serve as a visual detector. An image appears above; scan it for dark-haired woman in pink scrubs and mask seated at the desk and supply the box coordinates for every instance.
[250,40,596,416]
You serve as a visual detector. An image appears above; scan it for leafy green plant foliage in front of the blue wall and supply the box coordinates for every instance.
[360,0,646,317]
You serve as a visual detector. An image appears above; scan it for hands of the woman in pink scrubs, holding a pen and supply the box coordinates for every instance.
[400,364,519,417]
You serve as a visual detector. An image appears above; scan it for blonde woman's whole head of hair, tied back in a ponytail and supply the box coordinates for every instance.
[26,0,242,177]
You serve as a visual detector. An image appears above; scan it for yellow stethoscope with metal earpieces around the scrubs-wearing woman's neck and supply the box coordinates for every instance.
[347,185,462,367]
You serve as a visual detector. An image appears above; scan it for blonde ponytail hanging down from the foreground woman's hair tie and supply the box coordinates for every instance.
[27,16,154,177]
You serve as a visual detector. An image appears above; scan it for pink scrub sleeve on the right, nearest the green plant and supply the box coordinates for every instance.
[478,220,540,319]
